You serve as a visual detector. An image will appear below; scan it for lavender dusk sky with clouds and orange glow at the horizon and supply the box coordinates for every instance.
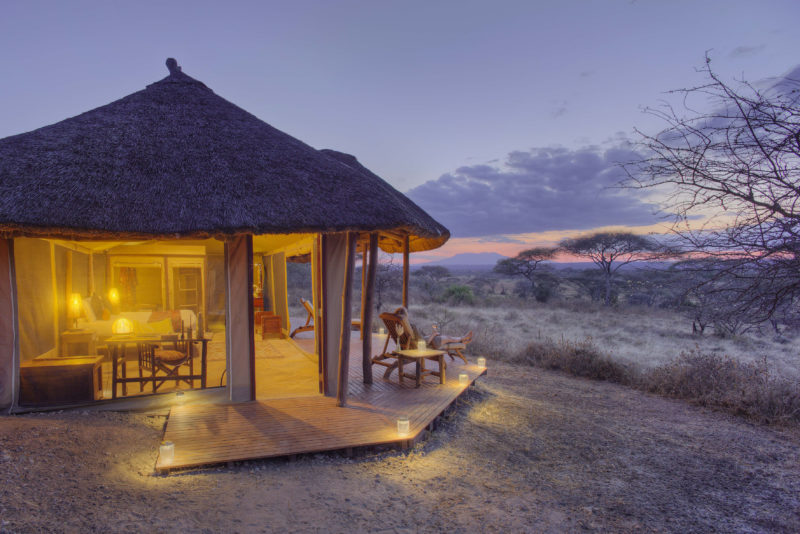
[0,0,800,261]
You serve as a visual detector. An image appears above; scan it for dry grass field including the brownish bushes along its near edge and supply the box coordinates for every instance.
[412,303,800,430]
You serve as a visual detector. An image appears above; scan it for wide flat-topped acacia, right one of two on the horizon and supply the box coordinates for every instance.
[559,232,665,306]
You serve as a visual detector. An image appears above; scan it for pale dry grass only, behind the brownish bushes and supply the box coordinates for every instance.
[411,302,800,377]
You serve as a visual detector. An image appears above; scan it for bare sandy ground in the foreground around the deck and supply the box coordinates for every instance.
[0,363,800,532]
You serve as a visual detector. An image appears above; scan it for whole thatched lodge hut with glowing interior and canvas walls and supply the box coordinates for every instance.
[0,59,449,408]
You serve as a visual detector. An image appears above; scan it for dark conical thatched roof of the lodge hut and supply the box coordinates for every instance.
[0,60,449,251]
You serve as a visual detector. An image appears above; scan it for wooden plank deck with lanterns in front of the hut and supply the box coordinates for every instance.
[156,342,486,472]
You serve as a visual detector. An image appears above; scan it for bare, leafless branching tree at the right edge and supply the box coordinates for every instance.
[624,57,800,320]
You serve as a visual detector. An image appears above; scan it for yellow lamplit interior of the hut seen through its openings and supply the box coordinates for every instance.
[14,234,320,407]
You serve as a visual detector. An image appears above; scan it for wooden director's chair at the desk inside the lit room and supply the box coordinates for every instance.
[138,329,195,393]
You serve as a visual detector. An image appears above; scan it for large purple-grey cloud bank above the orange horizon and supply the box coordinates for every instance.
[408,146,659,237]
